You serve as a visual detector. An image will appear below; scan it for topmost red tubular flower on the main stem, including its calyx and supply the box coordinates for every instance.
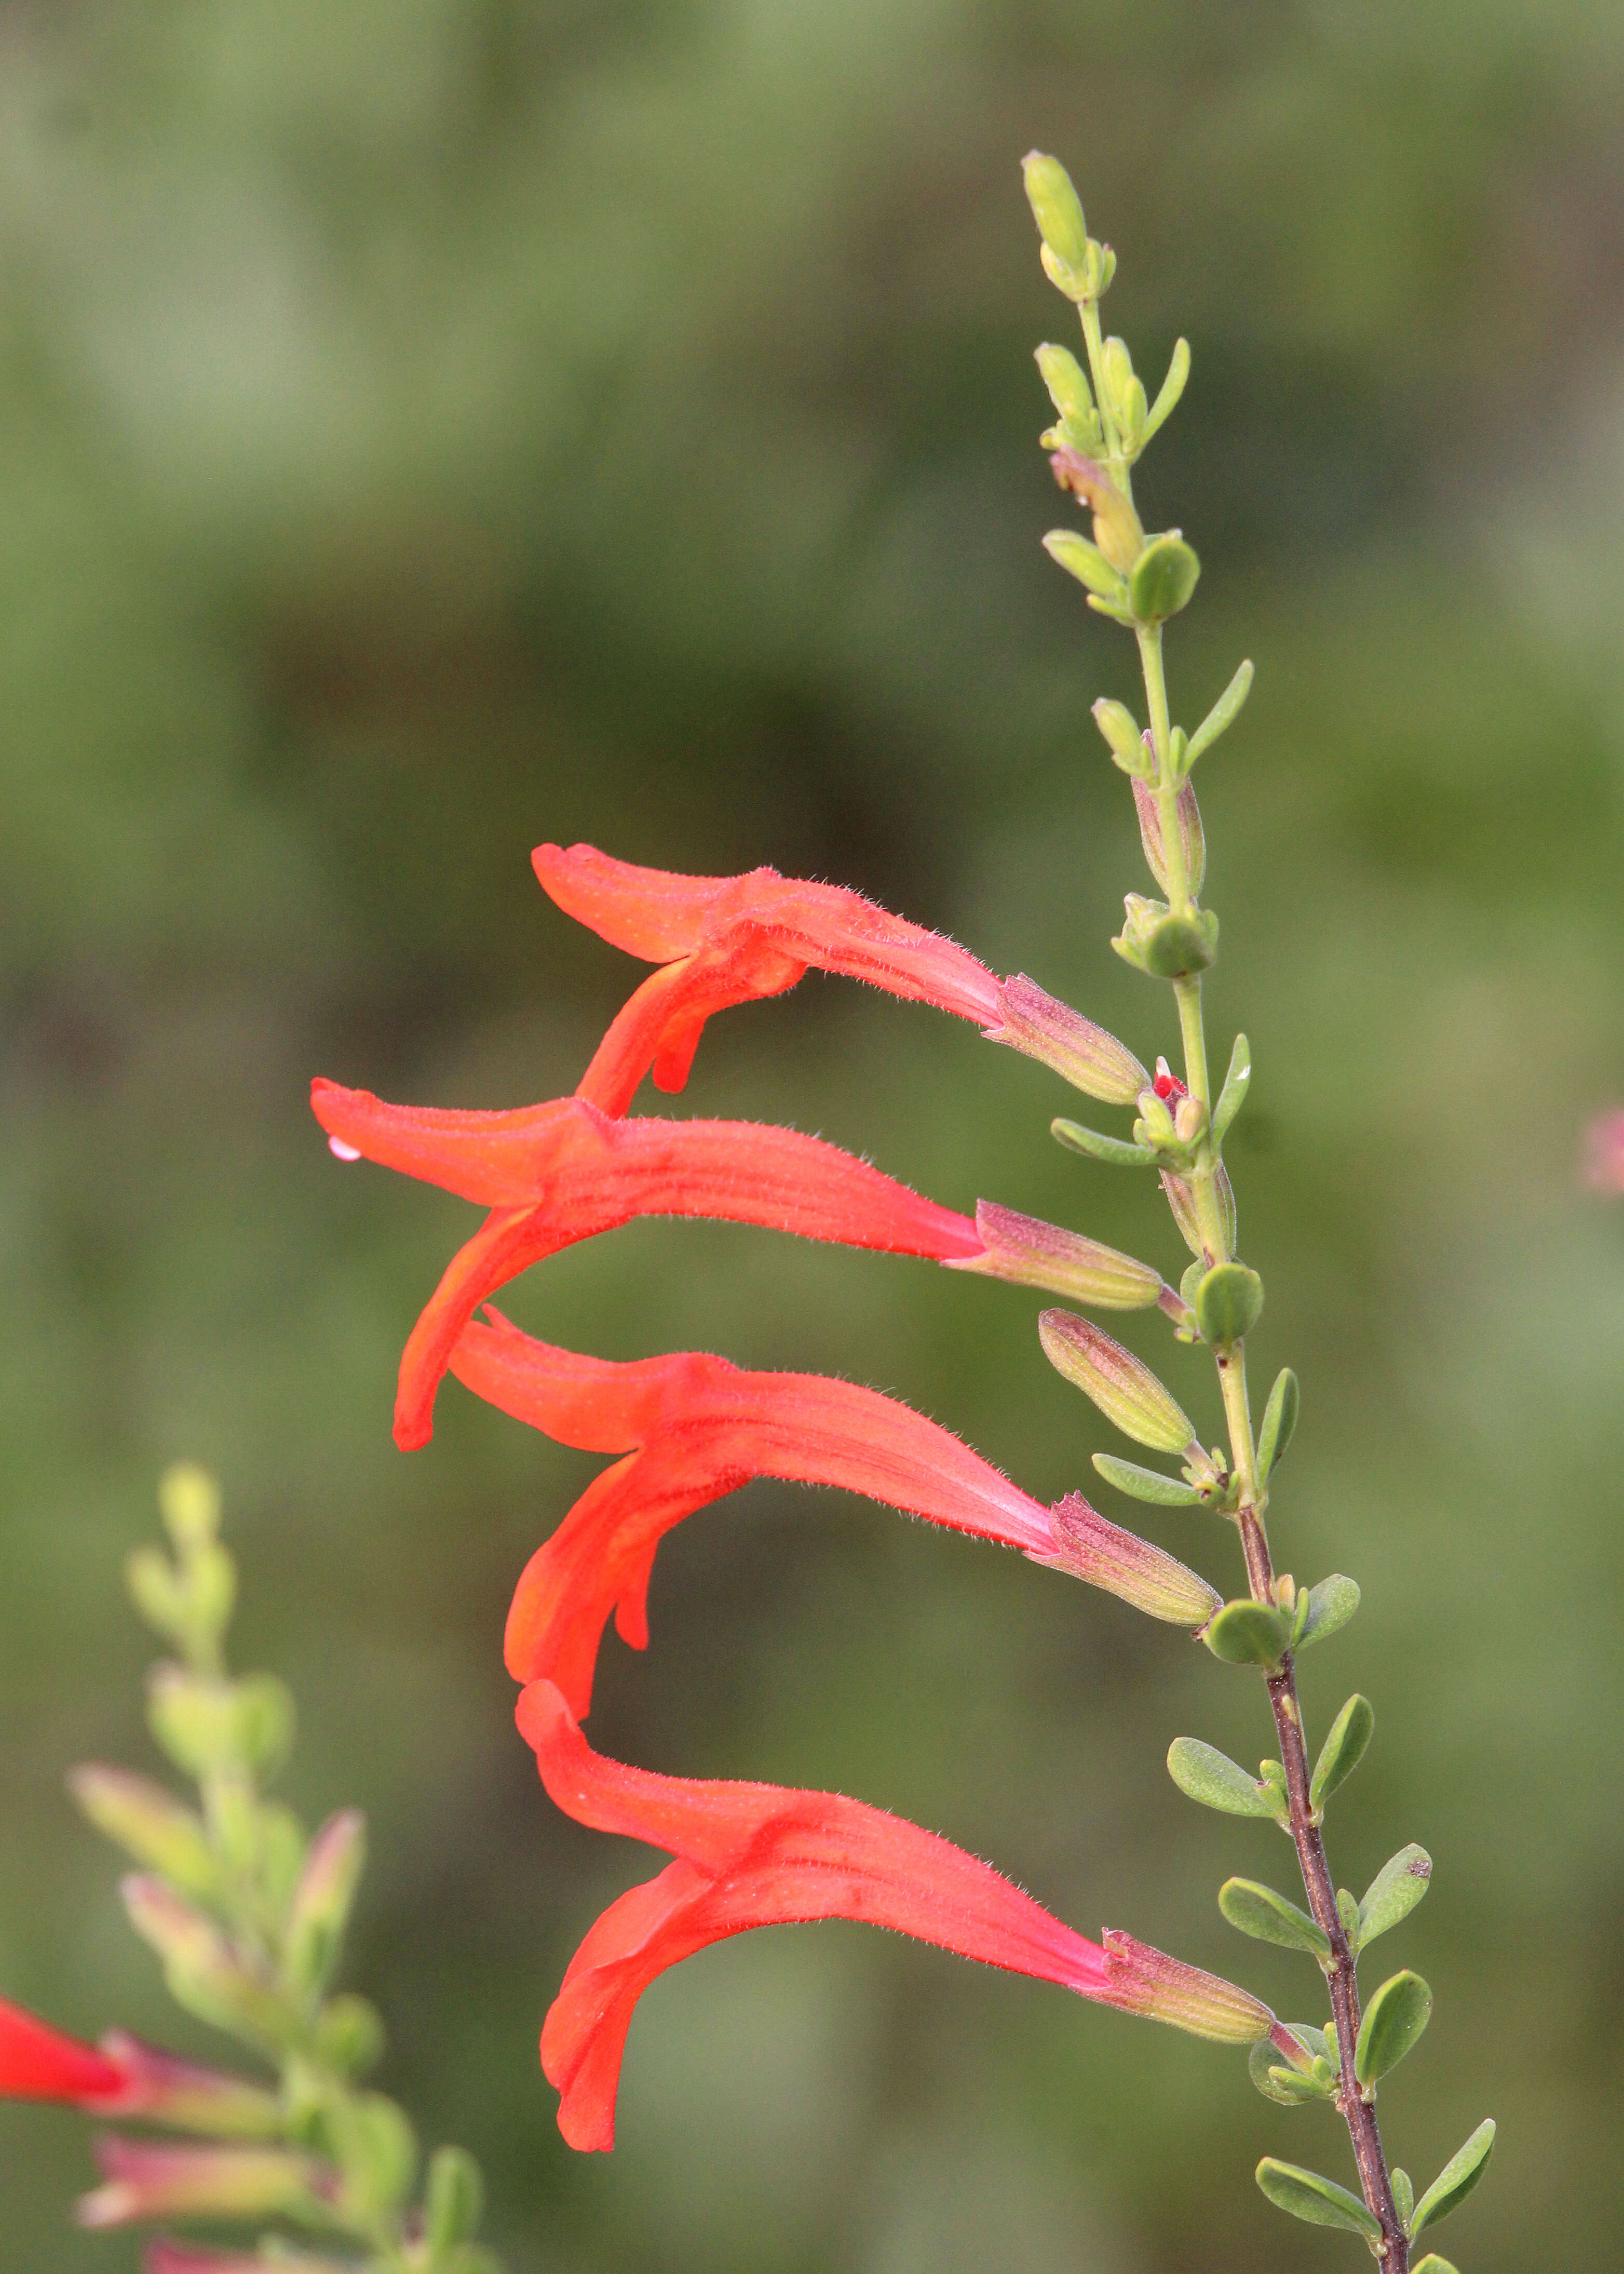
[532,846,1146,1114]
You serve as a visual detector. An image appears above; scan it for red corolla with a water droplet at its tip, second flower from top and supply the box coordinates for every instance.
[312,1080,980,1448]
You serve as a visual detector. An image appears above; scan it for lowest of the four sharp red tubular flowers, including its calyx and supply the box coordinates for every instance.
[516,1683,1274,2149]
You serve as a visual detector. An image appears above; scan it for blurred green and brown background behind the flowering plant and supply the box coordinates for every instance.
[0,0,1624,2274]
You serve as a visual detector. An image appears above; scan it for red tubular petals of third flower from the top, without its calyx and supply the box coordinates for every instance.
[450,1314,1055,1717]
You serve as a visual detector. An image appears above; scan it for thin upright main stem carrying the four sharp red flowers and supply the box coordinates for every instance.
[1132,623,1410,2274]
